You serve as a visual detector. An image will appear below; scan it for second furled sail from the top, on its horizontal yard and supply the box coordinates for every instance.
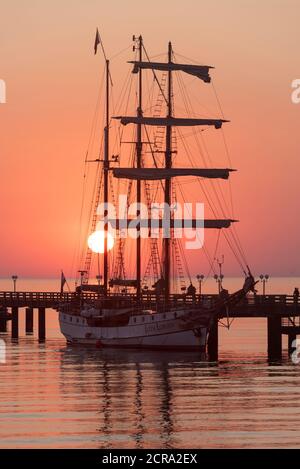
[113,116,229,129]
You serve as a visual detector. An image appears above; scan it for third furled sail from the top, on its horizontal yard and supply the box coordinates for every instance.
[113,168,234,181]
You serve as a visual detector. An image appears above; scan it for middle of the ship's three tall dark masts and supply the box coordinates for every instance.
[136,36,143,299]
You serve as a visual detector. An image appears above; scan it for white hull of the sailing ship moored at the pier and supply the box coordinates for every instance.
[59,310,209,352]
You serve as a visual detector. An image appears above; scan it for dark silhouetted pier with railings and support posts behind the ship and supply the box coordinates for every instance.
[0,291,300,360]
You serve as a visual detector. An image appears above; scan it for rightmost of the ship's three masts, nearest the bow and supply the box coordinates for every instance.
[163,42,173,303]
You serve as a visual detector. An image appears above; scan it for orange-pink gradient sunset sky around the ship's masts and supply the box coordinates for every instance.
[0,0,300,276]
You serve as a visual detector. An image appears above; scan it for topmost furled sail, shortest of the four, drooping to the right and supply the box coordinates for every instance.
[129,61,214,83]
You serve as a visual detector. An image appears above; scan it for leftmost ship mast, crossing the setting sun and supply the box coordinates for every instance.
[103,59,110,295]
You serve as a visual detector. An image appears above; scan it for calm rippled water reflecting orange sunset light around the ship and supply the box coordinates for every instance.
[0,279,300,448]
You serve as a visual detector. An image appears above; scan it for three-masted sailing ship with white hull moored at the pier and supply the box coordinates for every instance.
[59,31,255,352]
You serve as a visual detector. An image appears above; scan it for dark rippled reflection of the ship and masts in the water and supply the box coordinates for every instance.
[61,348,204,448]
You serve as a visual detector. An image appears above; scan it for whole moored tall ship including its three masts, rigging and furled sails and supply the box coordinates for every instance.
[59,30,254,352]
